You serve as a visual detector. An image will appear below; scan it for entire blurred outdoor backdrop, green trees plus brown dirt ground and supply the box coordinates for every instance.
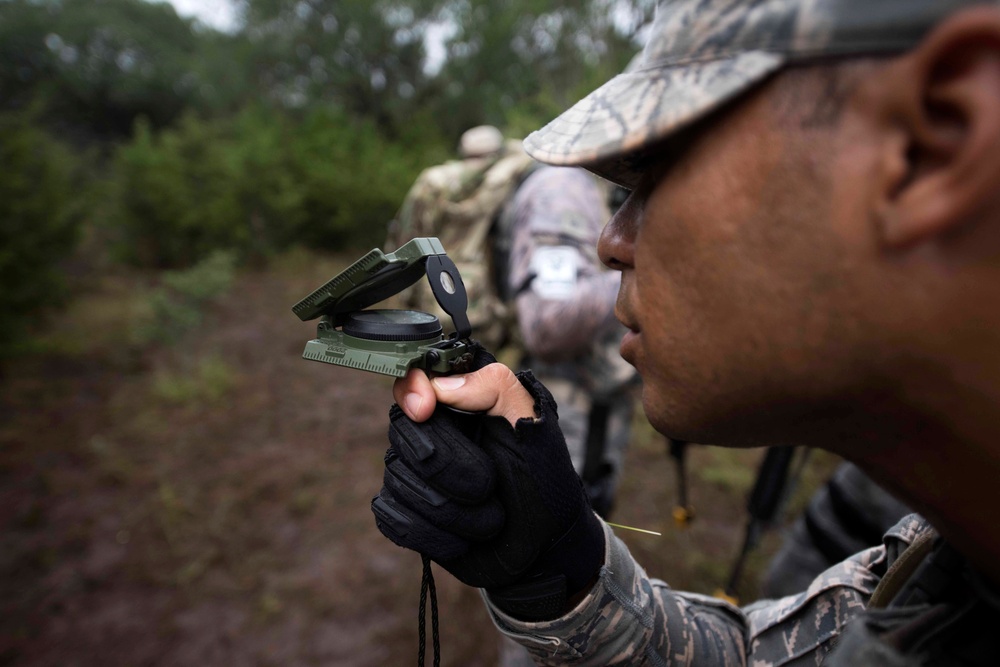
[0,0,833,666]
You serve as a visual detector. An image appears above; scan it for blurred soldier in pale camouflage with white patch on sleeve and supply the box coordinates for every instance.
[497,167,637,517]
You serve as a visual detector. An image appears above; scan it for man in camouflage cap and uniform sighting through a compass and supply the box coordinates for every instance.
[373,0,1000,666]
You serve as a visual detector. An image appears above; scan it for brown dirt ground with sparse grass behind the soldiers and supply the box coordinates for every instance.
[0,260,830,667]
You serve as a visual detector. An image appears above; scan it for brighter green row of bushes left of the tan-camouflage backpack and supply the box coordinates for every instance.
[109,108,441,267]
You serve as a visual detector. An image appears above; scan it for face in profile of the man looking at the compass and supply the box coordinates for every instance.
[599,75,869,445]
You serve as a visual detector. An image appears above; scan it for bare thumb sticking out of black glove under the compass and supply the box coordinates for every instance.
[431,364,537,426]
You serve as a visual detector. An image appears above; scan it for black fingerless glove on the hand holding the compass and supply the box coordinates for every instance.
[372,372,604,621]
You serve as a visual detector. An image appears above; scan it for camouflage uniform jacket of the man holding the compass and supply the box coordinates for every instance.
[483,514,1000,667]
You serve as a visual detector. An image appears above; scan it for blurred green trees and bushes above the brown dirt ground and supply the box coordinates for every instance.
[0,0,654,345]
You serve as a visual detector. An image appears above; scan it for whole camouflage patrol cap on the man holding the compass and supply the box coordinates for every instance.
[524,0,998,188]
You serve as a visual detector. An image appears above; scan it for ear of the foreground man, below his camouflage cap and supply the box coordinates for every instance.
[876,6,1000,246]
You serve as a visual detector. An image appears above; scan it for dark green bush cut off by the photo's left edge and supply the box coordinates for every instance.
[0,115,79,356]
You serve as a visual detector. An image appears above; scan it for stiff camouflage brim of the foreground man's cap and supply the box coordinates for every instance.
[524,51,785,188]
